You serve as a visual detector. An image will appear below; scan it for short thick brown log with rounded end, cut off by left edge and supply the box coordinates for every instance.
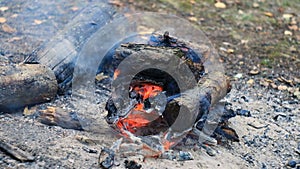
[0,64,58,112]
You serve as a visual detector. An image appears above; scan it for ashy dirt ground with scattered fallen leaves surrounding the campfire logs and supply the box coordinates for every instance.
[0,0,300,169]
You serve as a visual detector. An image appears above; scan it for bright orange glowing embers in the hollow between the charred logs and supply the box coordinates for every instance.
[117,83,163,133]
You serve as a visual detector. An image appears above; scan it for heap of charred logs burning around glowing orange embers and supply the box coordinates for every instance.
[105,32,235,156]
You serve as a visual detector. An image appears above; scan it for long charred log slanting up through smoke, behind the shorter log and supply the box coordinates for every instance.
[25,3,116,94]
